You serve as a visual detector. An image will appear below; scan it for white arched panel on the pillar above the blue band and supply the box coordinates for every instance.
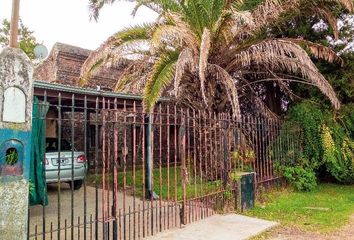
[2,87,26,123]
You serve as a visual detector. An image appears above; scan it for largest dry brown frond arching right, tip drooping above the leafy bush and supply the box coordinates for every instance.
[227,40,340,109]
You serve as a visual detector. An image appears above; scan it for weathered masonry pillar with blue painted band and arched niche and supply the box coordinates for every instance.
[0,48,33,240]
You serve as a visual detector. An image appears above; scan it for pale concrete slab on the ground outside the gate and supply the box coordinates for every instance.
[147,214,278,240]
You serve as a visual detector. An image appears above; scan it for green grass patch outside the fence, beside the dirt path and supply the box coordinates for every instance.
[246,184,354,233]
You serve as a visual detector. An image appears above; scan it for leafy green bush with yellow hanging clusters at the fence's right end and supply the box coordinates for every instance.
[277,101,354,190]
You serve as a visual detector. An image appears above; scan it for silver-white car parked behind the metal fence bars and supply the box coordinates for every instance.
[45,138,87,190]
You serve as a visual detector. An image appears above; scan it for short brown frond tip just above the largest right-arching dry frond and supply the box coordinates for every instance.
[284,38,344,66]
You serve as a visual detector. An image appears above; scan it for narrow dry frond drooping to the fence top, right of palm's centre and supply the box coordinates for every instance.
[208,64,241,120]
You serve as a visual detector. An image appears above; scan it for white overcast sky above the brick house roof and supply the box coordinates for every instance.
[0,0,156,50]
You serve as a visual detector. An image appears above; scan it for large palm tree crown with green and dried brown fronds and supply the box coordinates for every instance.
[80,0,353,117]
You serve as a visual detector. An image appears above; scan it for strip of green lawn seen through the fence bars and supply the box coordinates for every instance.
[87,166,220,201]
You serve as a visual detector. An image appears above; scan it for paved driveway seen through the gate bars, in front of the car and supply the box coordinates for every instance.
[29,183,180,240]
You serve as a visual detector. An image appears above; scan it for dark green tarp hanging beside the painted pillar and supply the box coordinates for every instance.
[29,98,48,206]
